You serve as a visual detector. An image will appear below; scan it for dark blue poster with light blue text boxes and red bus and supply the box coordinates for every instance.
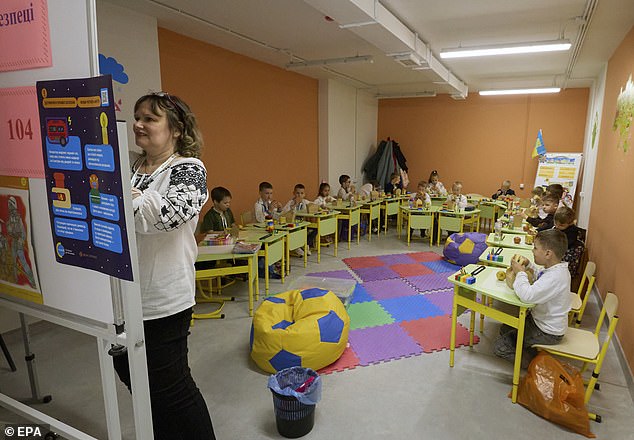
[37,75,132,281]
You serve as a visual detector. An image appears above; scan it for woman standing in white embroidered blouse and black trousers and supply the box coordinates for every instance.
[114,92,215,440]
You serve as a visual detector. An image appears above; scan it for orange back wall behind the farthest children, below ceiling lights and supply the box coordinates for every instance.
[378,89,588,197]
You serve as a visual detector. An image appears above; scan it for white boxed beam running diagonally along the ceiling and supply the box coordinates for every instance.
[304,0,469,97]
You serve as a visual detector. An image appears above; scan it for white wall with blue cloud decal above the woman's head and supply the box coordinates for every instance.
[97,1,161,151]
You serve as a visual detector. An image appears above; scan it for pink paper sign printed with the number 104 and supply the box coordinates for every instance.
[0,87,44,178]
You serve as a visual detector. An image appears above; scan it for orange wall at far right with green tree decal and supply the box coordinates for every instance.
[588,28,634,369]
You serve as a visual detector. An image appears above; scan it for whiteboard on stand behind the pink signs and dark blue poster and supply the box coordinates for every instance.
[0,0,136,324]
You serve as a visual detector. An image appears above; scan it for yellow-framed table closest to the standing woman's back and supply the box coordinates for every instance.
[192,246,259,319]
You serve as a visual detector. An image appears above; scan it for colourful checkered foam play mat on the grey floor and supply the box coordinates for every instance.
[308,252,479,374]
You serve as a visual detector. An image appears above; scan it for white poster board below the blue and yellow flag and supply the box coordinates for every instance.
[534,153,583,208]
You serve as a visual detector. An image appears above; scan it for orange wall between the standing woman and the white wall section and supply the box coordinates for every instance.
[158,28,319,222]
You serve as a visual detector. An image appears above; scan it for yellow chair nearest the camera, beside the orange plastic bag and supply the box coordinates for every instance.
[533,292,619,423]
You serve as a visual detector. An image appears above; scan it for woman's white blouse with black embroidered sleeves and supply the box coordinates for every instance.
[132,157,207,319]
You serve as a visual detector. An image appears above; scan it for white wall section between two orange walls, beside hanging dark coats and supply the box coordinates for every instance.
[319,80,378,187]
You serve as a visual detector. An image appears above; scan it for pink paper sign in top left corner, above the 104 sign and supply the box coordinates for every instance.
[0,0,52,72]
